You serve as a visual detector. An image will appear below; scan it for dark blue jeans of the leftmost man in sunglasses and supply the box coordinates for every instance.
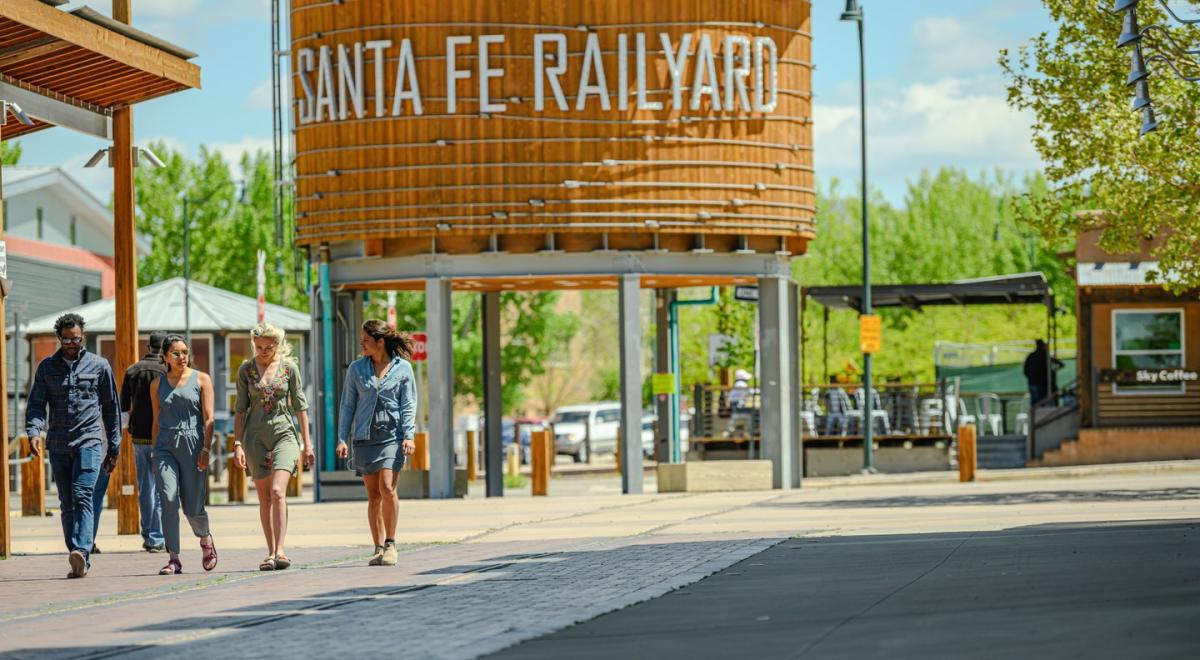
[50,443,104,564]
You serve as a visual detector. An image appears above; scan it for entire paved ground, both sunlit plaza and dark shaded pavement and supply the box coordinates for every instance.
[0,466,1200,659]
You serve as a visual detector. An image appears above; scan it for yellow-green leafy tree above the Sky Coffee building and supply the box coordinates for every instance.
[1000,0,1200,290]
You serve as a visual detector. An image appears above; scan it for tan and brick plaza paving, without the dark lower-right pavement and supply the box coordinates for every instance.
[0,464,1200,658]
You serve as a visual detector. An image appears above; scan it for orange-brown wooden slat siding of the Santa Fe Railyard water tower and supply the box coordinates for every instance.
[290,0,815,257]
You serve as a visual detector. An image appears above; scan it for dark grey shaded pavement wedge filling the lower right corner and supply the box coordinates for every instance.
[491,521,1200,660]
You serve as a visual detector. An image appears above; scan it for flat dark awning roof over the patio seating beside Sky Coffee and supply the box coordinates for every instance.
[804,272,1054,311]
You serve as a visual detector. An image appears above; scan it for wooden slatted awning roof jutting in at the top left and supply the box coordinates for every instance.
[0,0,200,139]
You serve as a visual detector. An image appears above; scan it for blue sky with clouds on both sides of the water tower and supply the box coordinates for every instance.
[20,0,1052,203]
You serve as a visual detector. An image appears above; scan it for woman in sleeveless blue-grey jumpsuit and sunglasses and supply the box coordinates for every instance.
[150,335,217,575]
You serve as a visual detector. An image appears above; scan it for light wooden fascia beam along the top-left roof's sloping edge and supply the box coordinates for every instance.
[0,0,200,89]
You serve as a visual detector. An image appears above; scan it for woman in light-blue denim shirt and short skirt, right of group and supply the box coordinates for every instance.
[337,319,416,566]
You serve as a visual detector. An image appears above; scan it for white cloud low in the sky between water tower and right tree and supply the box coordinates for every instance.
[814,77,1040,197]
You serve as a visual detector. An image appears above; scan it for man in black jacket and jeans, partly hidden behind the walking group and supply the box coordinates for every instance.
[119,331,167,552]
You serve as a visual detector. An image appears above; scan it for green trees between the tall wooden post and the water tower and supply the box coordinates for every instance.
[136,143,308,310]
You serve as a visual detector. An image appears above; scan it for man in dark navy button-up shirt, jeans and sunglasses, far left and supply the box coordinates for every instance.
[24,313,121,577]
